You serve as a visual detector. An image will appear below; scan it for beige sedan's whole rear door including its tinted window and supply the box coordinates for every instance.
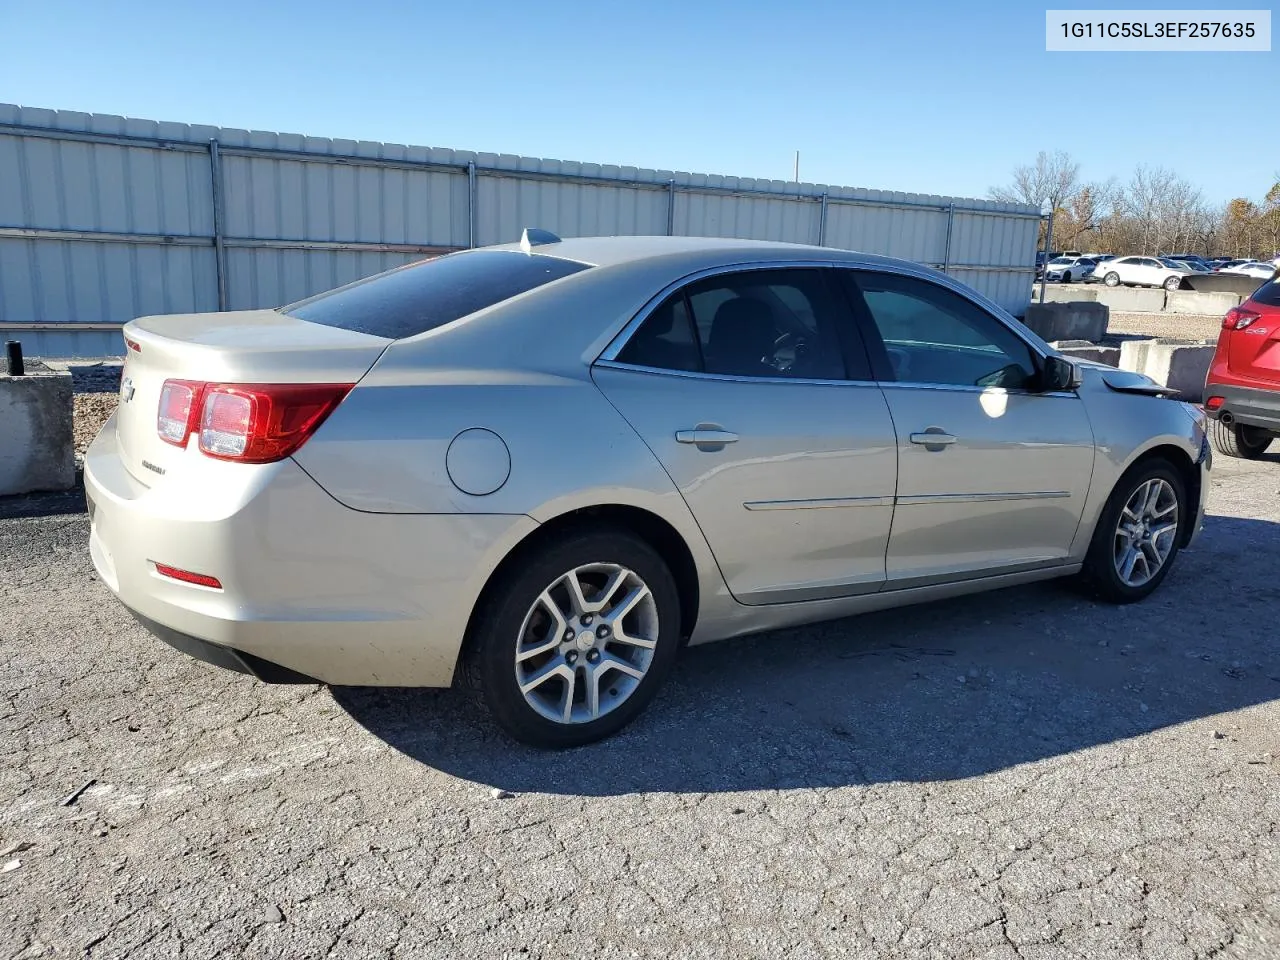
[593,268,897,604]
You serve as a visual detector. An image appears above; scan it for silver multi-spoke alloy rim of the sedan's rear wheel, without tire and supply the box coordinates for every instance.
[515,563,658,723]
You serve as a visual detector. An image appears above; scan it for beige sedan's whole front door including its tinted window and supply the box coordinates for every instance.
[852,271,1093,589]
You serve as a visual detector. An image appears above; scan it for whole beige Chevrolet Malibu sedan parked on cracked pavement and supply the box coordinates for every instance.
[84,230,1210,746]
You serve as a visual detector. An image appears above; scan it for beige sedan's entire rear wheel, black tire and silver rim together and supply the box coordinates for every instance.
[462,529,680,748]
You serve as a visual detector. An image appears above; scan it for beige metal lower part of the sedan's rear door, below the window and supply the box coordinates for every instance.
[594,364,896,603]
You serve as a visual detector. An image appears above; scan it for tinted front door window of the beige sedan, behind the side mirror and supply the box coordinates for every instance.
[858,273,1036,389]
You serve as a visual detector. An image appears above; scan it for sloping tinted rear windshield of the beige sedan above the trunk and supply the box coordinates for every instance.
[280,250,589,339]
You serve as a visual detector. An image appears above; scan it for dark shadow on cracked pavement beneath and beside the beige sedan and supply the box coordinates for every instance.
[333,517,1280,795]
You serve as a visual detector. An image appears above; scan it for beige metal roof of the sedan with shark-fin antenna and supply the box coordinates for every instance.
[486,237,936,273]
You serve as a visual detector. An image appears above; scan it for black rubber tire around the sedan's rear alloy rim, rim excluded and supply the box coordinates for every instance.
[461,527,680,748]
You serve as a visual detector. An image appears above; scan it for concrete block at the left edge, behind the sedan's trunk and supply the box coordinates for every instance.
[0,367,76,495]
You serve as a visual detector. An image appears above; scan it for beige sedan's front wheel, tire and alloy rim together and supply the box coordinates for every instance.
[1082,460,1190,603]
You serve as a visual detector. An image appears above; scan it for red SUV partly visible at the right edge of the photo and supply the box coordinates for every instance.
[1204,276,1280,460]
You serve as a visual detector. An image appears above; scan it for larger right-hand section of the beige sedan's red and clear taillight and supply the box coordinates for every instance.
[200,384,352,463]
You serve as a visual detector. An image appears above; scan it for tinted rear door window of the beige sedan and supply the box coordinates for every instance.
[618,270,870,380]
